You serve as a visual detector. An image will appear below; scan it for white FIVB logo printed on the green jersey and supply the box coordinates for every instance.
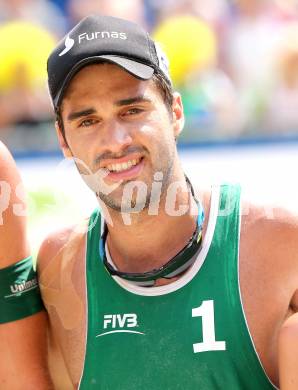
[96,313,144,337]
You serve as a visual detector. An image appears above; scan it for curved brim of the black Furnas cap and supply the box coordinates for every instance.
[54,55,154,107]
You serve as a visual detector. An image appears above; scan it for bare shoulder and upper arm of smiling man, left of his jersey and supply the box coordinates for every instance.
[37,224,86,389]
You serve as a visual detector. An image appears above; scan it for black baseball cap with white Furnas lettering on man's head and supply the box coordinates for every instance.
[47,15,171,108]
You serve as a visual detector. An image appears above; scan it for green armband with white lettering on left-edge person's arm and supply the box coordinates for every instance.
[0,256,43,324]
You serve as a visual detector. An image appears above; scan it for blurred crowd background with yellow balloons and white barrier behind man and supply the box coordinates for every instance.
[0,0,298,248]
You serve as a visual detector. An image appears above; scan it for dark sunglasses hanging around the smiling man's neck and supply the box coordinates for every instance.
[99,176,204,285]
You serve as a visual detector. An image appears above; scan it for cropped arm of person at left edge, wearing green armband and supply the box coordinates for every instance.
[0,143,52,390]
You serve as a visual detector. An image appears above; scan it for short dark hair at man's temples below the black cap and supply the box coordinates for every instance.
[55,65,174,144]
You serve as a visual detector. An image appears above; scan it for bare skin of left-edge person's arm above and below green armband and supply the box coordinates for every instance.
[0,143,52,390]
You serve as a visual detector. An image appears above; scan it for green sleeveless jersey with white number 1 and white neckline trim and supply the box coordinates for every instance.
[79,185,276,390]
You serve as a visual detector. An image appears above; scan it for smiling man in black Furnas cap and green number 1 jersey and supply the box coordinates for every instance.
[38,16,298,390]
